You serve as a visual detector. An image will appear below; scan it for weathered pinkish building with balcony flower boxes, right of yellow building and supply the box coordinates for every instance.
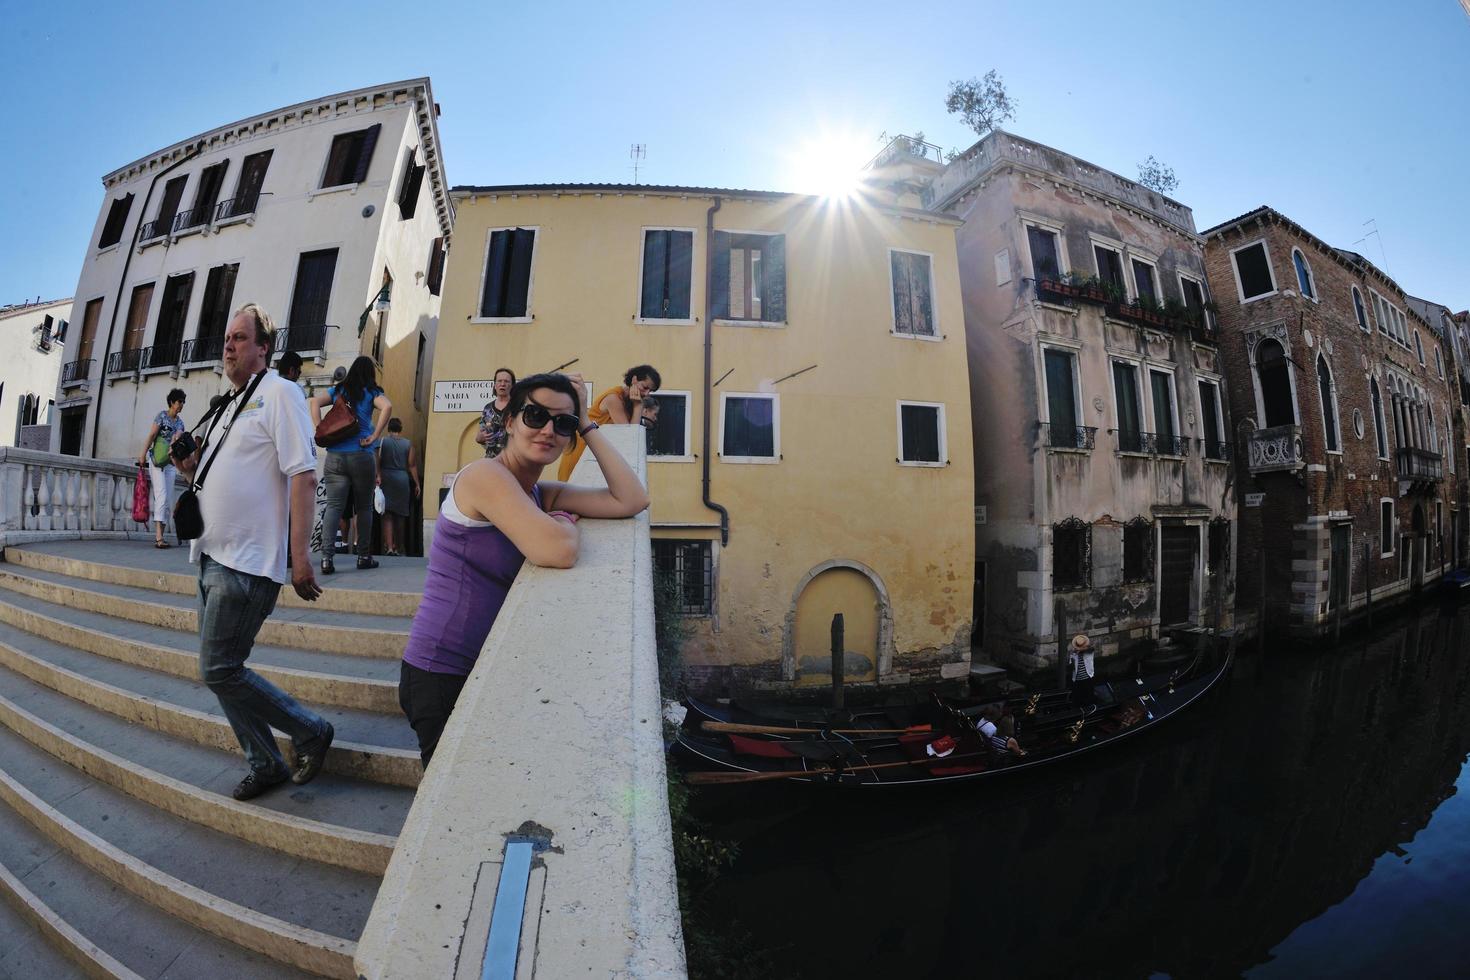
[922,132,1235,669]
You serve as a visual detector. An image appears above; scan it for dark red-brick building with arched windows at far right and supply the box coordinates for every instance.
[1202,207,1464,633]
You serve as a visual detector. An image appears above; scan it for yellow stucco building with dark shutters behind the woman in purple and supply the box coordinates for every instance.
[425,184,975,691]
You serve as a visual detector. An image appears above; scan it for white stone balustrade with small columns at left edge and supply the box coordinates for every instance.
[0,447,165,547]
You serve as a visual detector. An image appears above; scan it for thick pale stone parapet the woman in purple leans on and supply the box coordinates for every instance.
[356,426,685,980]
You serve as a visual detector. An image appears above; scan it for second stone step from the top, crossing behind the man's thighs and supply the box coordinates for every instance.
[0,566,410,660]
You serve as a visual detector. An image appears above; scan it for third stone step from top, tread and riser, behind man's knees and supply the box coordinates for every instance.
[0,595,398,713]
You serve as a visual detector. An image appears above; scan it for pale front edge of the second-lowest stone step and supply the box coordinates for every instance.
[0,768,357,980]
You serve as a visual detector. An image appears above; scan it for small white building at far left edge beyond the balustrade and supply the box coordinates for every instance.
[0,297,72,450]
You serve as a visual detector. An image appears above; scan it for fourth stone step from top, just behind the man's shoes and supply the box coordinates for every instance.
[0,623,422,788]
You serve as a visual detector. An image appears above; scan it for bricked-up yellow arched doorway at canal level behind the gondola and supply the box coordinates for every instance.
[782,561,892,685]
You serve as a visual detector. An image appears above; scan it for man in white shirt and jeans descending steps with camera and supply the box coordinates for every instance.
[179,304,332,799]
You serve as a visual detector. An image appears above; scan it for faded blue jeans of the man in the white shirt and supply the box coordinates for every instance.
[198,555,326,774]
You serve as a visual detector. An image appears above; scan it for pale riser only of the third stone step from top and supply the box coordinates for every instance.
[0,599,400,714]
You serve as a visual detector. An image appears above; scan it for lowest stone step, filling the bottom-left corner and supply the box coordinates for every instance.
[0,804,310,980]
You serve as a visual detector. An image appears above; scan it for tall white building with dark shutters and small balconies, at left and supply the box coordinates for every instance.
[51,78,453,552]
